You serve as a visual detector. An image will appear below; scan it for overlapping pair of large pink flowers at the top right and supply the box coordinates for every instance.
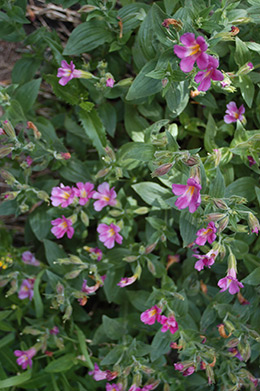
[174,33,224,91]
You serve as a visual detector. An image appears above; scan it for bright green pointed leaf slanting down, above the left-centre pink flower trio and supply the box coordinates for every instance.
[79,109,107,155]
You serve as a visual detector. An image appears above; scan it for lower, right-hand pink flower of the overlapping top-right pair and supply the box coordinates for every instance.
[194,56,224,91]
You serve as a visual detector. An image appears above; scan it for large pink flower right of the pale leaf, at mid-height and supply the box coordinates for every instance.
[172,178,201,213]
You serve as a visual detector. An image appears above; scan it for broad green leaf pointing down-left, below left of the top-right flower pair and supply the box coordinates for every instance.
[126,60,162,100]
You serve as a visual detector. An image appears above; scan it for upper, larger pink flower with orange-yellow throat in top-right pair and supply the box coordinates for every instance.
[174,33,209,73]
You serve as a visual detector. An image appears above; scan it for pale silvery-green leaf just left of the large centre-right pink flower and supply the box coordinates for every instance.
[132,182,171,209]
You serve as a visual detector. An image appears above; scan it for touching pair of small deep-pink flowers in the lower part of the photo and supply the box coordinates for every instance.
[140,305,179,334]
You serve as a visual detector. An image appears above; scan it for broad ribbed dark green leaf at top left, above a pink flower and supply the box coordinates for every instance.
[63,20,113,56]
